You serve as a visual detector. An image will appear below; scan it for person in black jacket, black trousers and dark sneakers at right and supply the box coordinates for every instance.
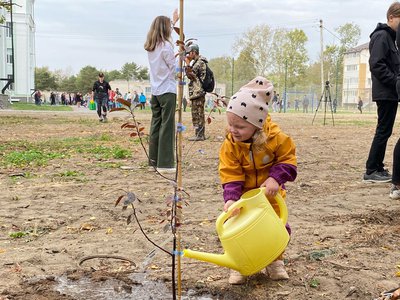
[364,2,400,182]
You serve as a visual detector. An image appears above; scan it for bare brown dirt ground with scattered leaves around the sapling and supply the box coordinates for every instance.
[0,109,400,300]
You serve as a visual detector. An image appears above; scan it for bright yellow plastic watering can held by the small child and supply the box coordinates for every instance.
[183,188,289,275]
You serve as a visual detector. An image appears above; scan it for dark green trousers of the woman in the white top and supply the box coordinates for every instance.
[149,93,176,168]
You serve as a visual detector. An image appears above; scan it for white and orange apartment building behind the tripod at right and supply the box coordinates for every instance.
[342,43,372,107]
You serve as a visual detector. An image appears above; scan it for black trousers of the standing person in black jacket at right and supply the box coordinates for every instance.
[366,101,398,174]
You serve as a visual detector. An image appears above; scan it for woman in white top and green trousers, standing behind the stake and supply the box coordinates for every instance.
[144,11,178,172]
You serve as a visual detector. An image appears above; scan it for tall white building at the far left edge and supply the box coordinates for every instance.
[0,0,36,101]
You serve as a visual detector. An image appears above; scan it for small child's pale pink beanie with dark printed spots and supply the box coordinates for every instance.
[226,76,274,128]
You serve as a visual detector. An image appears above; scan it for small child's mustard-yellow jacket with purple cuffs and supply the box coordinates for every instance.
[219,116,297,201]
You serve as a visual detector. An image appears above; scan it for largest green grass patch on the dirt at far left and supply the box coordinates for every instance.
[3,149,64,167]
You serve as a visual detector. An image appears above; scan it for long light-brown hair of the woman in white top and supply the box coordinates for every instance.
[144,16,172,52]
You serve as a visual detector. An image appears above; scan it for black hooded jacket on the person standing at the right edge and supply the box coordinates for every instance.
[369,23,400,101]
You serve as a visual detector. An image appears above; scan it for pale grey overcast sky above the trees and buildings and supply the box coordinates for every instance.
[35,0,393,73]
